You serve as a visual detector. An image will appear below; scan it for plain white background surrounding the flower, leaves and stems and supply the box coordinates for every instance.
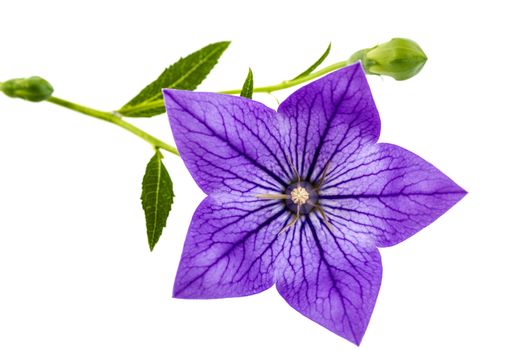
[0,0,525,350]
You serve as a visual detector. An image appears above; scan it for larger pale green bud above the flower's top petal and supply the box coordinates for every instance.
[350,38,427,80]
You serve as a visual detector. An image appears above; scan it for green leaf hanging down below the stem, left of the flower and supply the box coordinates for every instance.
[140,150,174,251]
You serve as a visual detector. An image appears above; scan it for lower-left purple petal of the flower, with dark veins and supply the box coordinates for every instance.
[173,194,290,299]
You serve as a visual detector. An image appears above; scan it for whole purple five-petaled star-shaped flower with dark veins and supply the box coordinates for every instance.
[164,63,466,344]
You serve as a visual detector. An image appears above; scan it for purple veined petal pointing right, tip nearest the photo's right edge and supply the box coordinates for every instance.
[320,143,466,247]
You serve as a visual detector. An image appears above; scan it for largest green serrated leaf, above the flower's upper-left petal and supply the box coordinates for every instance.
[122,41,230,117]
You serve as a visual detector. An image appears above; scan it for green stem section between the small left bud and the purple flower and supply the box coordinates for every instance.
[46,96,179,155]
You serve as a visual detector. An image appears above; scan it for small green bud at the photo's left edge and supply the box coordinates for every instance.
[0,77,53,102]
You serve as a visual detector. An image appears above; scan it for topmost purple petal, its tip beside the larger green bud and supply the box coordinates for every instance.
[278,63,380,182]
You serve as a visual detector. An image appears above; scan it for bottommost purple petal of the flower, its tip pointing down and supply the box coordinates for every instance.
[277,214,382,344]
